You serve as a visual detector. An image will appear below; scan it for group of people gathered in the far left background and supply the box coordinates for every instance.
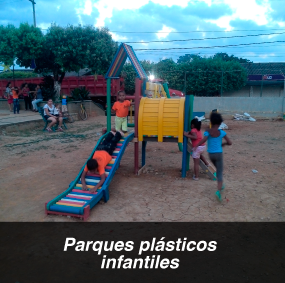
[5,82,43,114]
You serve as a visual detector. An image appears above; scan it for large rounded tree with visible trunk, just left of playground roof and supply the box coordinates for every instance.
[33,25,116,99]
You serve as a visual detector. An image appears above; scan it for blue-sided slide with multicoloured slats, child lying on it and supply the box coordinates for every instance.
[45,133,134,221]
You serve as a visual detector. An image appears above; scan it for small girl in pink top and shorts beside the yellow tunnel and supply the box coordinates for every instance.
[184,118,209,181]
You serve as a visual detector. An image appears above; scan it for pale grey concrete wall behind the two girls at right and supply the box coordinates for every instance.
[194,97,285,117]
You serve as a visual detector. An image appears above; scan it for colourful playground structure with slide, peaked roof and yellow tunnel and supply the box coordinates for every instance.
[45,44,214,220]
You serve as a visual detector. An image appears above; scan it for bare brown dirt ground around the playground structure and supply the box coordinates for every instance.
[0,117,285,222]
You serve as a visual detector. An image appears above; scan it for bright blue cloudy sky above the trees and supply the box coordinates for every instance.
[0,0,285,67]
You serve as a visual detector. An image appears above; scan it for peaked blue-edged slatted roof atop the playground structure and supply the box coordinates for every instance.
[105,43,147,79]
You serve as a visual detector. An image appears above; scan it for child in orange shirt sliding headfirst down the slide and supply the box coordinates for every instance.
[81,131,122,193]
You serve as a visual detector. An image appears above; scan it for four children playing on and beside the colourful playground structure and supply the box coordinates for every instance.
[81,91,232,201]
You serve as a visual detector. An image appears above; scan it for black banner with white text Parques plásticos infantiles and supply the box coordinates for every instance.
[0,223,285,283]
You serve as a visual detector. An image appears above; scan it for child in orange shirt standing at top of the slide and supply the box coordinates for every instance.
[112,90,134,133]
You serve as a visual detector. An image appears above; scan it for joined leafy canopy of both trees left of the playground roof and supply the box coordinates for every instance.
[0,24,117,99]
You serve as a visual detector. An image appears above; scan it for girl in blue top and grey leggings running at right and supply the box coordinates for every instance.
[193,113,232,201]
